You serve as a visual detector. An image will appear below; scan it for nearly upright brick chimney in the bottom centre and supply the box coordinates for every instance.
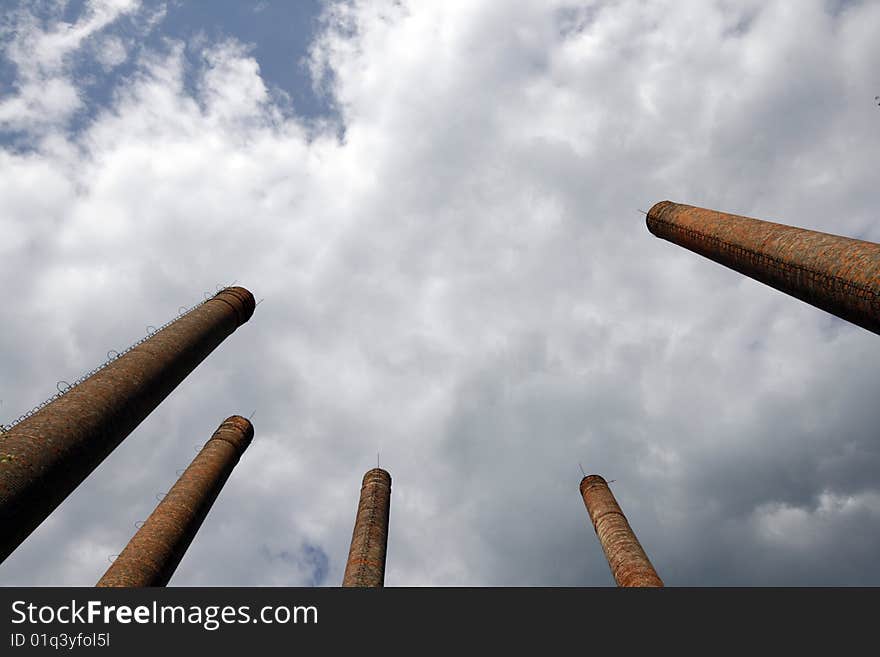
[342,468,391,586]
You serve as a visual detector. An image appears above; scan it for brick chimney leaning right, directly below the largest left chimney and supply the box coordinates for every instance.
[97,415,254,587]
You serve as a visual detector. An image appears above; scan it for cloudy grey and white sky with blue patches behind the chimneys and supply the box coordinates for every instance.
[0,0,880,586]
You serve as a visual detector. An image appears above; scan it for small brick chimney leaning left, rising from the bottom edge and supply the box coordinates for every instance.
[580,475,663,587]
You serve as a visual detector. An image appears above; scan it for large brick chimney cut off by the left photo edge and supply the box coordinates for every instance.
[0,287,255,562]
